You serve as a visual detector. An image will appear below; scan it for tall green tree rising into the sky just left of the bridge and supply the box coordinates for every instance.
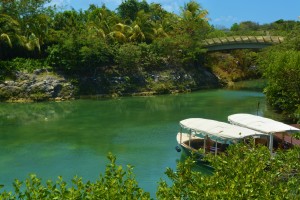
[158,1,211,65]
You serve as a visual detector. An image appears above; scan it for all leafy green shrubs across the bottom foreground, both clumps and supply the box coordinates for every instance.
[0,144,300,199]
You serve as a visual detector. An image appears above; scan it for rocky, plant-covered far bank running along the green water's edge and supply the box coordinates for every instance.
[0,67,221,102]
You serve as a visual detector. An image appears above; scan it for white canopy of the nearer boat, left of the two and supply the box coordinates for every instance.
[180,118,265,140]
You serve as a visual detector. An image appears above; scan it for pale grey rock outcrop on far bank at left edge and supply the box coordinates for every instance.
[0,69,74,101]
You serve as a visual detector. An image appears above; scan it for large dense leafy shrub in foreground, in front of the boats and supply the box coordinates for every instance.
[157,144,300,199]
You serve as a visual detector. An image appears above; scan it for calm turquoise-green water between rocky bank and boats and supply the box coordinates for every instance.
[0,90,269,197]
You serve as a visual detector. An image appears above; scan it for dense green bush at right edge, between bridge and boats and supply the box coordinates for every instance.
[260,51,300,118]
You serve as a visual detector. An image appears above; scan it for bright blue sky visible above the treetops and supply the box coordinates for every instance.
[52,0,300,28]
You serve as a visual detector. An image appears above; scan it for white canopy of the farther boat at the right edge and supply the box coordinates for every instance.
[228,113,300,134]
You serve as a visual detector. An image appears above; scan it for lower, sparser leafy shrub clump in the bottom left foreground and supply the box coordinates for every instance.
[0,154,150,200]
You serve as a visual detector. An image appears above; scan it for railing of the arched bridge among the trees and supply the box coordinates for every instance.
[204,36,284,46]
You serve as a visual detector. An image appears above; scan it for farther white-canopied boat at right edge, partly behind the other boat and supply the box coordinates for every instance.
[228,113,300,152]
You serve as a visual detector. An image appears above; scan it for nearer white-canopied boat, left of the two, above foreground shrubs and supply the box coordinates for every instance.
[176,118,268,158]
